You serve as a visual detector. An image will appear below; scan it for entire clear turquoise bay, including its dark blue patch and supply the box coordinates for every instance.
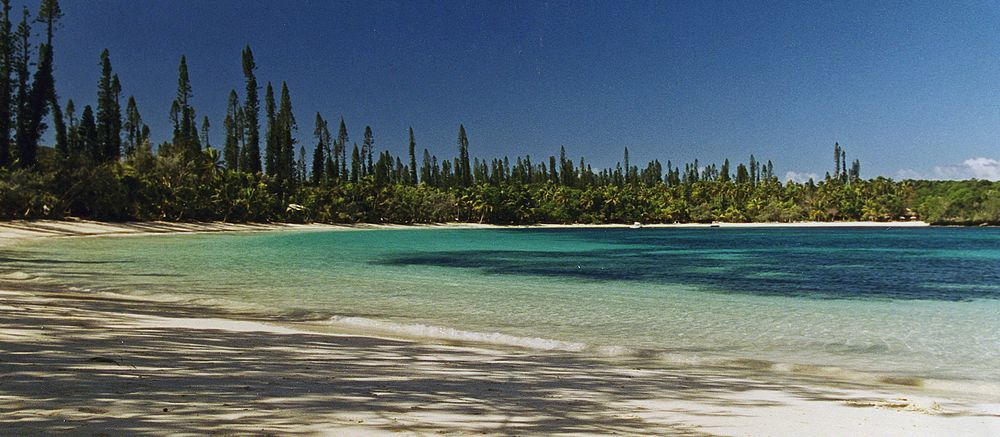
[0,228,1000,396]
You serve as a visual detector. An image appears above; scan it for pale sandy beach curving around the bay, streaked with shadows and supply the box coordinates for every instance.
[0,221,1000,436]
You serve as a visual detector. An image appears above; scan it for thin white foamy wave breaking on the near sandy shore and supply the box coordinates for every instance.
[328,316,587,352]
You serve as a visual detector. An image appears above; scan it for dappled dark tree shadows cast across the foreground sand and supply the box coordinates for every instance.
[0,284,992,435]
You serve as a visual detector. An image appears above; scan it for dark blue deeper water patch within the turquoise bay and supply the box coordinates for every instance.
[378,228,1000,301]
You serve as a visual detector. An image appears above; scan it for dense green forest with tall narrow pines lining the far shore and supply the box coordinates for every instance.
[0,0,1000,224]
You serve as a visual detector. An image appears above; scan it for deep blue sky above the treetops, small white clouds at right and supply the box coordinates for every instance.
[15,0,1000,179]
